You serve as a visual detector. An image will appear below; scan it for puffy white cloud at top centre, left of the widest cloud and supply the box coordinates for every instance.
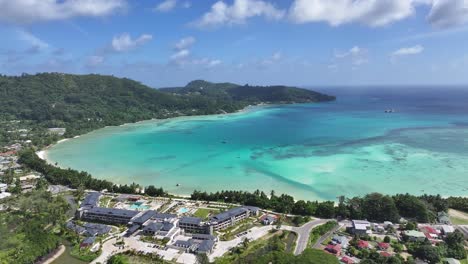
[195,0,285,28]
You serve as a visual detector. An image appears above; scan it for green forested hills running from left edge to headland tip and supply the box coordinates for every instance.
[0,73,331,136]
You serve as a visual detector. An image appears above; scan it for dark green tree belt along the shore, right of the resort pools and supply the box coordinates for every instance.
[191,190,458,223]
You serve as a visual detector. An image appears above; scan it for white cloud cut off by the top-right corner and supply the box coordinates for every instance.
[427,0,468,28]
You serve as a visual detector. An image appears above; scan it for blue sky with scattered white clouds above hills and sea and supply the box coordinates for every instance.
[0,0,468,87]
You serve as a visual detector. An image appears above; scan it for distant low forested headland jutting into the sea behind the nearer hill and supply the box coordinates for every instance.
[160,80,335,104]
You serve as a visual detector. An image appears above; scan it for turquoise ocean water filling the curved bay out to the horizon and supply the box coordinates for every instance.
[47,87,468,200]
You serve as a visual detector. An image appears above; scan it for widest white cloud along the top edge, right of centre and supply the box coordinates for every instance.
[289,0,427,27]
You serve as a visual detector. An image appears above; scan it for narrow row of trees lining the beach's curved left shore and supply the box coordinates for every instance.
[19,150,167,196]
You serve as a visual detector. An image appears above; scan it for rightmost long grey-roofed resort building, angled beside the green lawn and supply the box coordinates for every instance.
[210,206,260,231]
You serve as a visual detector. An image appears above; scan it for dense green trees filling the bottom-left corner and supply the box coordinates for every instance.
[0,190,69,263]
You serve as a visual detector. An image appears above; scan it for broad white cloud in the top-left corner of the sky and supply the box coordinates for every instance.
[0,0,126,24]
